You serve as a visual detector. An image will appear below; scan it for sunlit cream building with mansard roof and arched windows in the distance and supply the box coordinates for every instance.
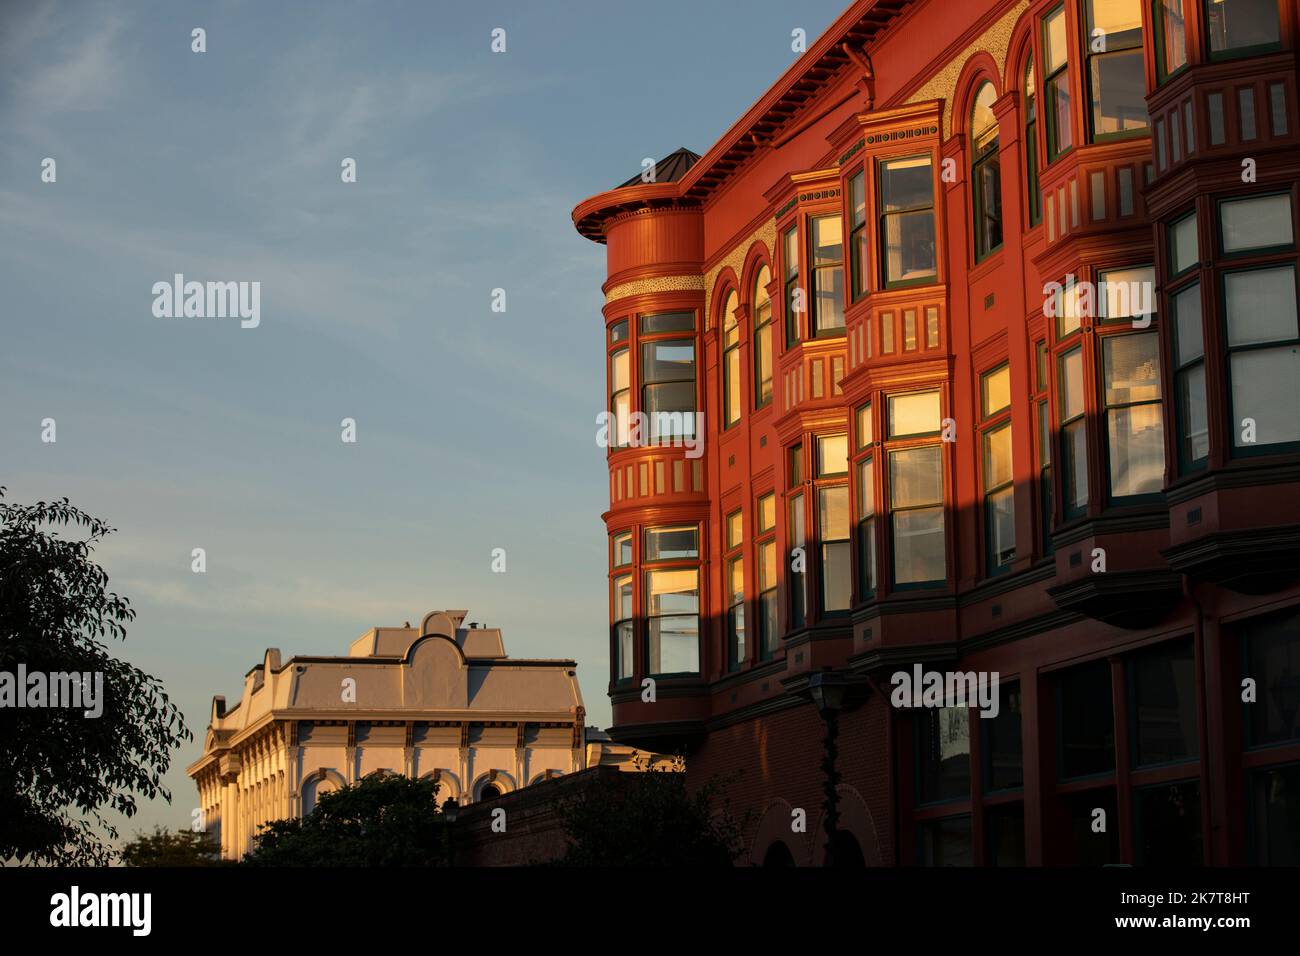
[187,611,624,858]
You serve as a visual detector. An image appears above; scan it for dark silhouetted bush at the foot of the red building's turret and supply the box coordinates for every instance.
[558,770,744,866]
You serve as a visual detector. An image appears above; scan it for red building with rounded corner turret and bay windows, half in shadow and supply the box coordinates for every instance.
[573,0,1300,865]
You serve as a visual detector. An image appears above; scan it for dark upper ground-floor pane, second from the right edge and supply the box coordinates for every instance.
[1130,641,1200,766]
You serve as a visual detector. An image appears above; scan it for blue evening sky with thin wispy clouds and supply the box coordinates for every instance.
[0,0,844,834]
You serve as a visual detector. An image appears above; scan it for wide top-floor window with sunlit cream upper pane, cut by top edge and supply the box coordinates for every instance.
[1084,0,1148,140]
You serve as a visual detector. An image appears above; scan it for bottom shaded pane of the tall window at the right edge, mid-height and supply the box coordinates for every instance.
[1229,346,1300,447]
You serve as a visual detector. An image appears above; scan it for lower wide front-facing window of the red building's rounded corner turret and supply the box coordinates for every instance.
[644,525,699,675]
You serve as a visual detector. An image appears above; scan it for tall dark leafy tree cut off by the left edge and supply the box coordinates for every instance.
[0,488,191,865]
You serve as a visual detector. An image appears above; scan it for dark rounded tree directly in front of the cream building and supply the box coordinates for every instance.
[244,773,450,866]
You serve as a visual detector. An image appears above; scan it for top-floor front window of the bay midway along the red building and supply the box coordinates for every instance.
[878,155,936,286]
